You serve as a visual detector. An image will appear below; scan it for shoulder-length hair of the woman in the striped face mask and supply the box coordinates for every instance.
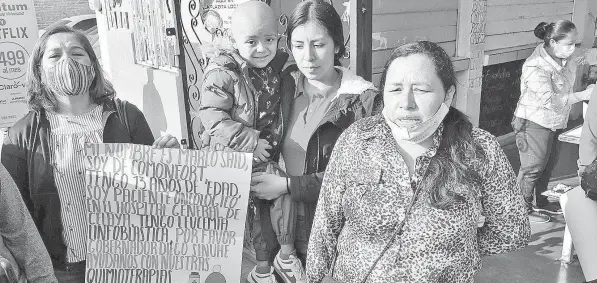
[27,26,115,110]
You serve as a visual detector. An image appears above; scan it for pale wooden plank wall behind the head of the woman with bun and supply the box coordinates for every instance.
[485,0,574,51]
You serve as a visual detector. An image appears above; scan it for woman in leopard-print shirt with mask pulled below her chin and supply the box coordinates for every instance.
[307,41,530,283]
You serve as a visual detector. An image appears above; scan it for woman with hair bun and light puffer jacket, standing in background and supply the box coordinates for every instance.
[512,20,594,223]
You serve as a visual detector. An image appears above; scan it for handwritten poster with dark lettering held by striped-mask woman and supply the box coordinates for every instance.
[85,144,251,283]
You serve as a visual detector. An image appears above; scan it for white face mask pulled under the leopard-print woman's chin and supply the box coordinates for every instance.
[382,102,450,143]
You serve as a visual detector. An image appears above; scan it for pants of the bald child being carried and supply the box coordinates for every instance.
[251,161,296,261]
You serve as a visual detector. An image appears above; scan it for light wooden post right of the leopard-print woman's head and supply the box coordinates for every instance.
[456,0,487,126]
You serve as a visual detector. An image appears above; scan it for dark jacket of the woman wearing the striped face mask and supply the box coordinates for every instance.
[1,99,154,270]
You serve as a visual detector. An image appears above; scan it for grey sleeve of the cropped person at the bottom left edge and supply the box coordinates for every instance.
[0,164,58,283]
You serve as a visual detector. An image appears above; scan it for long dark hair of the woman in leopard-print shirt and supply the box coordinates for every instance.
[380,41,484,209]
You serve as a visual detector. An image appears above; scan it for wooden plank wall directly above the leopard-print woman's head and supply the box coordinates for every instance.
[372,0,458,84]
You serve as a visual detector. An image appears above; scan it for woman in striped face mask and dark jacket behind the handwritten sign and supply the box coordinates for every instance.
[2,26,179,283]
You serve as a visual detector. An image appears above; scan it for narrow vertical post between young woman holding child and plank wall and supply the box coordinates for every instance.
[349,0,373,81]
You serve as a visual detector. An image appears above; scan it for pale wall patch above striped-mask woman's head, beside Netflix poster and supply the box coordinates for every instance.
[34,0,93,29]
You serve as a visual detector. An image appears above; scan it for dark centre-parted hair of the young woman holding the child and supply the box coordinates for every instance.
[286,0,346,66]
